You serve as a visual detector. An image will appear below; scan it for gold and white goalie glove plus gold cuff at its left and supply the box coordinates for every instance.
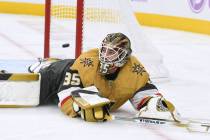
[60,87,112,122]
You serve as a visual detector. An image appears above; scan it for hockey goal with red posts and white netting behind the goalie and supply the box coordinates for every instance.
[44,0,168,79]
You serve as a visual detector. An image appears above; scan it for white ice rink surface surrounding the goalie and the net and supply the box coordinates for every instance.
[0,15,210,140]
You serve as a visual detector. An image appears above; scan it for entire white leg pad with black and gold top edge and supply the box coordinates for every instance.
[0,73,40,107]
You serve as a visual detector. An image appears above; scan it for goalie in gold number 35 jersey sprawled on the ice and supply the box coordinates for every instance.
[3,33,175,121]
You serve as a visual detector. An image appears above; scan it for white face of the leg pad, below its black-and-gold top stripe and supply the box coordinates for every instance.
[0,76,41,107]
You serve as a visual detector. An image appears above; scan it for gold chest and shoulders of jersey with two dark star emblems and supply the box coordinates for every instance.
[71,49,149,110]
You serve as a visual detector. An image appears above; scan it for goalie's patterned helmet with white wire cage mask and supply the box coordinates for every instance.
[99,33,132,74]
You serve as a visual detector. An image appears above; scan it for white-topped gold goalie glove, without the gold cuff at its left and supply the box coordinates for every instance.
[72,86,112,122]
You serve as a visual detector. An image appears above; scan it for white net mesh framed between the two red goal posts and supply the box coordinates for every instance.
[50,0,77,58]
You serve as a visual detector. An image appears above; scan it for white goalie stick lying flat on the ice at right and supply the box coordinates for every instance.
[114,116,210,133]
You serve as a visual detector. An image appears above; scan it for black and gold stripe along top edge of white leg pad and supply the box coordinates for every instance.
[0,73,39,81]
